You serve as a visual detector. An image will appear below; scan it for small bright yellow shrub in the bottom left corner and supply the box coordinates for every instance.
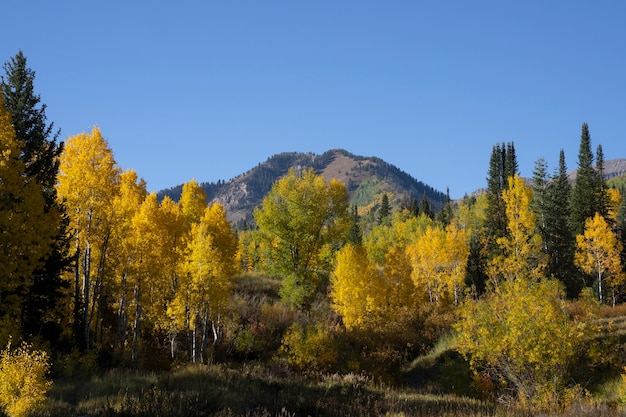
[0,341,52,417]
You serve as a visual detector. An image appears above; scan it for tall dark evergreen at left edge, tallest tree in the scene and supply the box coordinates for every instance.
[2,51,70,340]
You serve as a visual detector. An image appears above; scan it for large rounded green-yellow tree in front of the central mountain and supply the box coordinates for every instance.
[254,169,350,310]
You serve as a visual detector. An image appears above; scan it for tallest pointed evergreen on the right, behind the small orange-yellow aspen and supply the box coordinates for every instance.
[570,123,599,235]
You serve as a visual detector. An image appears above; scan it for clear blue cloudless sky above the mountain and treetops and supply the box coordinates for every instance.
[0,0,626,198]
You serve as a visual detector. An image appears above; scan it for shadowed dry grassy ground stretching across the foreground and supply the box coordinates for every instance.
[35,275,626,417]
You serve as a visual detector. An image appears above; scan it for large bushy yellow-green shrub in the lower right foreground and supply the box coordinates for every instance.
[455,279,594,408]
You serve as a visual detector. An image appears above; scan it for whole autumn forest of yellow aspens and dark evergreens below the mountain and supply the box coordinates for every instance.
[0,52,626,417]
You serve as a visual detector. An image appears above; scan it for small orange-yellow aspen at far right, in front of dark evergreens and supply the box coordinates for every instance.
[574,213,626,304]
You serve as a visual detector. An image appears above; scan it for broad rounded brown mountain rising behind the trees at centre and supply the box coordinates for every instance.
[158,149,446,222]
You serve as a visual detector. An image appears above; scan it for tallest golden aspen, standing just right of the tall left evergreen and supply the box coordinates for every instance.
[57,127,120,349]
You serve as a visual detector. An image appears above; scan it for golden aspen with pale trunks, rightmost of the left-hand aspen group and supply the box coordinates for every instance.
[176,204,239,362]
